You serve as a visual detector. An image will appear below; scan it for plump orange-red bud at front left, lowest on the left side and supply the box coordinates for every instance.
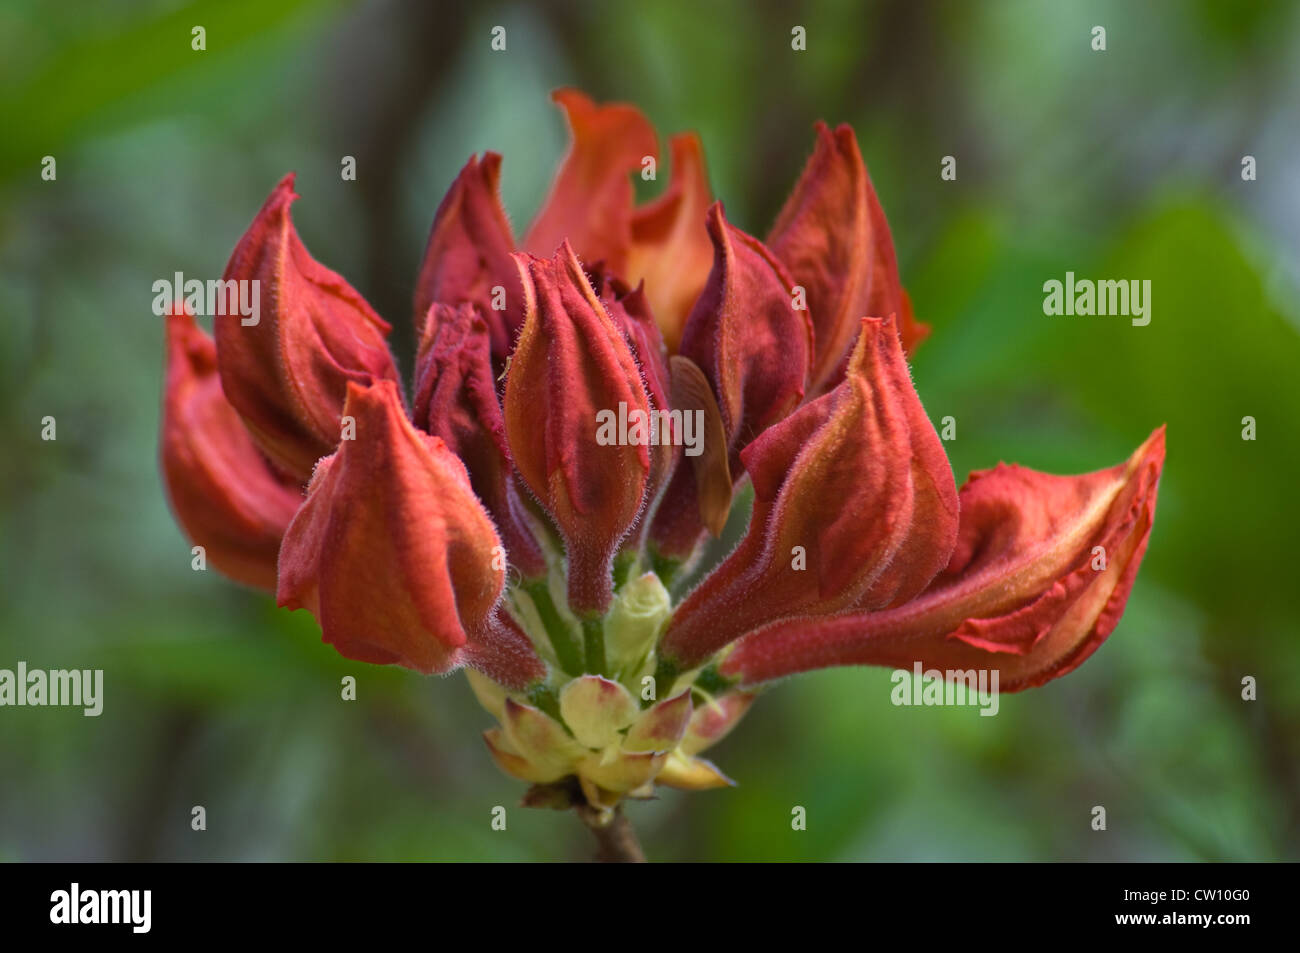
[278,381,545,688]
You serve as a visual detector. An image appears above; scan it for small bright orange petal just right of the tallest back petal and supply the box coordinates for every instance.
[628,133,714,352]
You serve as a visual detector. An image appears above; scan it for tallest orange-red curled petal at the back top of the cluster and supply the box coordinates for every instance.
[524,90,659,274]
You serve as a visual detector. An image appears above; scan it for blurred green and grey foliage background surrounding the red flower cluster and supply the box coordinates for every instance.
[0,0,1300,861]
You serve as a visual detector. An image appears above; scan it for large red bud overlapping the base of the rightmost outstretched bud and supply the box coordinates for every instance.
[662,319,957,670]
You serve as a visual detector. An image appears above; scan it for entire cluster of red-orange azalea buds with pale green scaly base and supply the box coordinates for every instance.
[161,90,1165,858]
